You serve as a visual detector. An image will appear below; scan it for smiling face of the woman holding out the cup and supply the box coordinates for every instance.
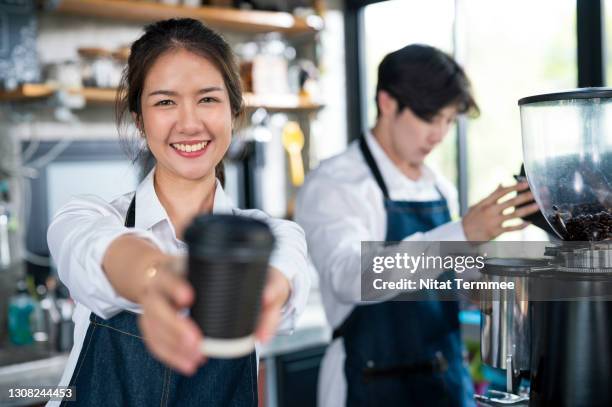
[141,49,232,180]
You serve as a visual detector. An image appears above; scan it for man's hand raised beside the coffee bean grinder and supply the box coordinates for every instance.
[462,182,539,242]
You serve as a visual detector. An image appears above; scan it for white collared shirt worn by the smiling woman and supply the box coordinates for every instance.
[47,170,311,405]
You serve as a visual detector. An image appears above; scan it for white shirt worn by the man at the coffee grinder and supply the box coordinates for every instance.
[295,133,465,407]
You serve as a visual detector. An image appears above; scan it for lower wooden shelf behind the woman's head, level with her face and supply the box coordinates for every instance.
[0,84,323,111]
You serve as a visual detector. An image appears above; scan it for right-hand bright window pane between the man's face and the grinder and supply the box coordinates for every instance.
[457,0,577,207]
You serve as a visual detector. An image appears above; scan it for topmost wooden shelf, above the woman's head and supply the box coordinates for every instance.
[56,0,323,34]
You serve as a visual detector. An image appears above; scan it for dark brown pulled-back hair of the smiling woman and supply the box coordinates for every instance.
[115,18,244,183]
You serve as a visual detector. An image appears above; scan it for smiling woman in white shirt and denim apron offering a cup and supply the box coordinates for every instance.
[48,19,309,406]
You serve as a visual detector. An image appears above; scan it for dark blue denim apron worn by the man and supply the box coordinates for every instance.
[334,137,474,407]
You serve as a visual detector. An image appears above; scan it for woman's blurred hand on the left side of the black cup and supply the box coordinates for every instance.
[138,256,205,375]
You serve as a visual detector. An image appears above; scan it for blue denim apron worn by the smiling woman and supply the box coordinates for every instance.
[62,197,257,407]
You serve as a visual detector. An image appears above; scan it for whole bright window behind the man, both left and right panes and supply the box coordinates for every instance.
[363,0,572,237]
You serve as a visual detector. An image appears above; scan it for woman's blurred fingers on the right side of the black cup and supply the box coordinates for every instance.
[255,267,291,342]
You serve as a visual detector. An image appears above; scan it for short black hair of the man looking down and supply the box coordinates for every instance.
[376,44,479,121]
